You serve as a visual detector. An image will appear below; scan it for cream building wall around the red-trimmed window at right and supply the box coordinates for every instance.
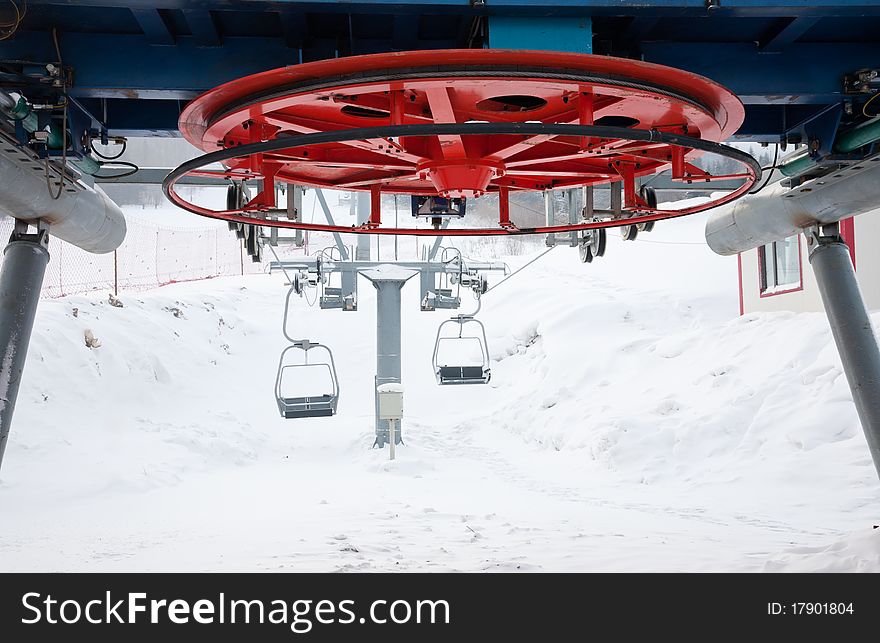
[739,210,880,313]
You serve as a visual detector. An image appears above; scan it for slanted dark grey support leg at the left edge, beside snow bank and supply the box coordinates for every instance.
[0,230,49,464]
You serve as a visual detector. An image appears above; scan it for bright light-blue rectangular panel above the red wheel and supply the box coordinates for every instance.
[489,15,593,54]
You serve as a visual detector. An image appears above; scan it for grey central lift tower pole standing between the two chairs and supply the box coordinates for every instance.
[361,264,416,449]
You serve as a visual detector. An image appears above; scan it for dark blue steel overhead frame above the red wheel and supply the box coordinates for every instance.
[10,0,880,141]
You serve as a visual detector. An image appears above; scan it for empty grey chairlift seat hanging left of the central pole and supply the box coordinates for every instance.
[275,339,339,419]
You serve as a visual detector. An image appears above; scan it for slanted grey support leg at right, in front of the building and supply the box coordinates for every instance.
[807,233,880,476]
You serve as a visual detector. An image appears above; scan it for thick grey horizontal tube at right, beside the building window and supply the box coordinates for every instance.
[706,161,880,255]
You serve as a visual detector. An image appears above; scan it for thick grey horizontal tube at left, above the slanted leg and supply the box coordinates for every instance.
[0,149,125,254]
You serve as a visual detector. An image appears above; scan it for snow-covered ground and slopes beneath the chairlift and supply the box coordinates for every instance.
[0,208,880,571]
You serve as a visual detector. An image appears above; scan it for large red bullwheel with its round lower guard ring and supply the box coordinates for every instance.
[165,49,760,234]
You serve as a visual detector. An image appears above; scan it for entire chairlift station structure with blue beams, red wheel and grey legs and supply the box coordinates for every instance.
[0,0,880,476]
